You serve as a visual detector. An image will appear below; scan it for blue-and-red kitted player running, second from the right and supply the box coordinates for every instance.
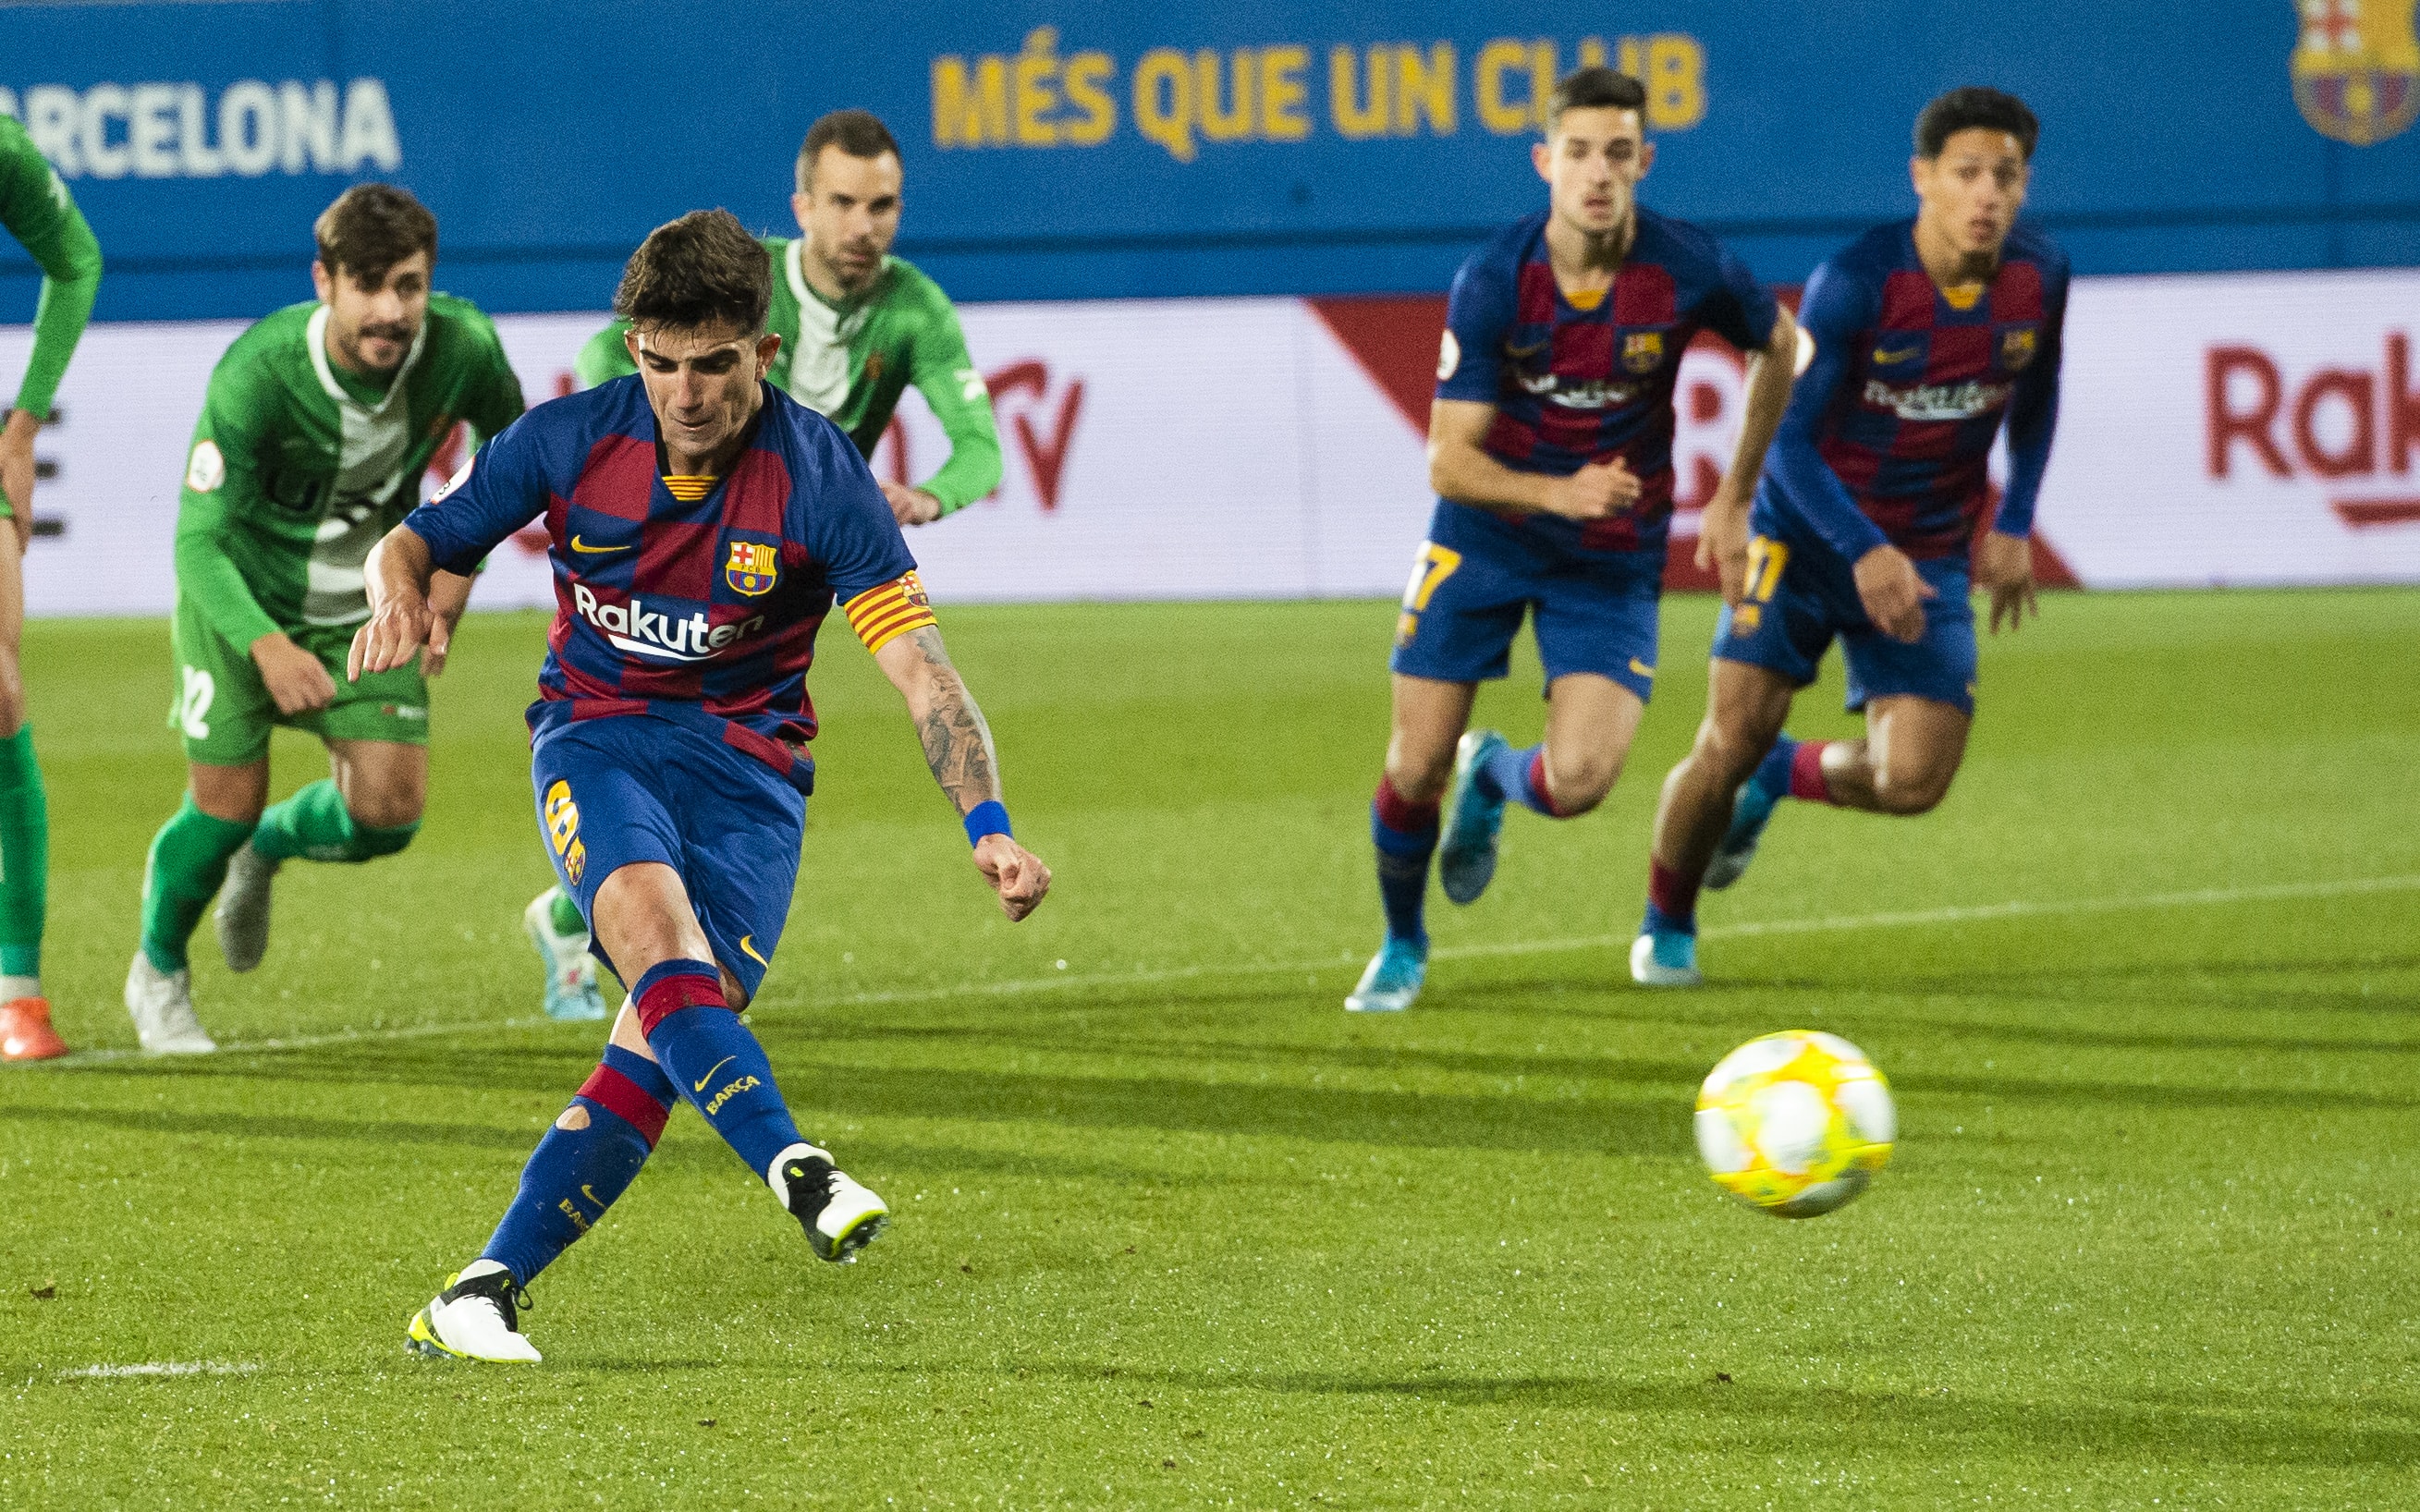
[1346,67,1798,1014]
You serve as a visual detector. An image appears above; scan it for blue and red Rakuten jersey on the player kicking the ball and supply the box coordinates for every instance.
[404,377,932,786]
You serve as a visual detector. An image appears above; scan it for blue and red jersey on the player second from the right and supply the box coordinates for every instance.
[1437,208,1777,552]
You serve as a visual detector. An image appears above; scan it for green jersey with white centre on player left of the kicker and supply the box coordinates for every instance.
[177,295,522,651]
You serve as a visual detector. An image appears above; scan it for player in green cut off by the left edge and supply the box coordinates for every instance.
[0,116,102,1060]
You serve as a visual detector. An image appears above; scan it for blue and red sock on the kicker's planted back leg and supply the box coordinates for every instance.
[479,1045,673,1285]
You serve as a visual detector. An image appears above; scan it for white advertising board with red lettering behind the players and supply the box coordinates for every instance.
[0,271,2420,615]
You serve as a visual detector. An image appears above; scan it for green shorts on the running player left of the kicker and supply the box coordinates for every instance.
[167,600,428,767]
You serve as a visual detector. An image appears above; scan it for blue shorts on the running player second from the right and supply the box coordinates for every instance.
[1387,498,1663,699]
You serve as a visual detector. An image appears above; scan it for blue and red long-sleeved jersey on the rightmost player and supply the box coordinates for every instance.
[1759,220,2067,561]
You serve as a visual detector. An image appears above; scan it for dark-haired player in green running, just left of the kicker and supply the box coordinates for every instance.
[126,184,520,1055]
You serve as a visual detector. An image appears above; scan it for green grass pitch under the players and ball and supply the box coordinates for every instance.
[0,592,2420,1507]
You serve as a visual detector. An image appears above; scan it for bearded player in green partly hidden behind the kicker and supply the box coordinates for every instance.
[522,111,999,1018]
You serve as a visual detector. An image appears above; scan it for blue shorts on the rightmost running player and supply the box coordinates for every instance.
[1714,534,1974,713]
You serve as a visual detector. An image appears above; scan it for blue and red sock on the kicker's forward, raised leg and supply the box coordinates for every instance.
[631,960,803,1180]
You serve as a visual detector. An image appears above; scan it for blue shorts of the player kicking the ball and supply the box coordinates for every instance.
[530,713,806,996]
